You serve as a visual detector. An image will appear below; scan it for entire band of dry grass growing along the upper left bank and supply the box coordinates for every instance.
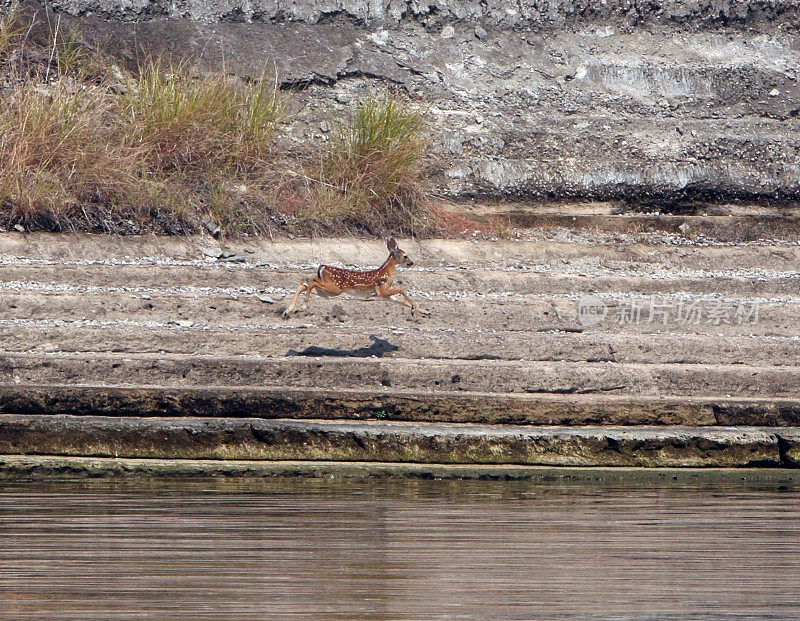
[0,13,444,234]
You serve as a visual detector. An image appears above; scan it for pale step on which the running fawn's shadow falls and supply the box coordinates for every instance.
[0,324,800,366]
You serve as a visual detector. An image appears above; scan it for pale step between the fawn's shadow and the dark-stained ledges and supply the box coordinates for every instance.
[6,354,800,400]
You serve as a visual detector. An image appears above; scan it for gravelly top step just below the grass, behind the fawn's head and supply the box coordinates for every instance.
[0,234,800,272]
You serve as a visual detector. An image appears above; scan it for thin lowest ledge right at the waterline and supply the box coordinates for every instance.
[0,455,800,489]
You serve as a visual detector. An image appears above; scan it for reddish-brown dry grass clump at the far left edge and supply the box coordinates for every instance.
[0,80,141,229]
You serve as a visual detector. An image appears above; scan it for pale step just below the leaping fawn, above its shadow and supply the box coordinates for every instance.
[0,290,800,338]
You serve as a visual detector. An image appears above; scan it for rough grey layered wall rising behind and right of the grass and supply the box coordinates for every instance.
[6,0,800,203]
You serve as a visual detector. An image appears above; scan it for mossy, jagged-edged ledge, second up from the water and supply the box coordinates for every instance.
[0,414,800,468]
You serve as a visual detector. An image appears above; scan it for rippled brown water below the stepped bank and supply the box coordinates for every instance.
[0,479,800,619]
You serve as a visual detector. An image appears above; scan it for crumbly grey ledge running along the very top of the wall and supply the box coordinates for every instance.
[26,0,800,30]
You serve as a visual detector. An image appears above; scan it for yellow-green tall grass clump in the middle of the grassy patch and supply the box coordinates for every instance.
[117,60,285,234]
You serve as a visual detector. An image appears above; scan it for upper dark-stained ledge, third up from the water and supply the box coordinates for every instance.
[0,384,800,427]
